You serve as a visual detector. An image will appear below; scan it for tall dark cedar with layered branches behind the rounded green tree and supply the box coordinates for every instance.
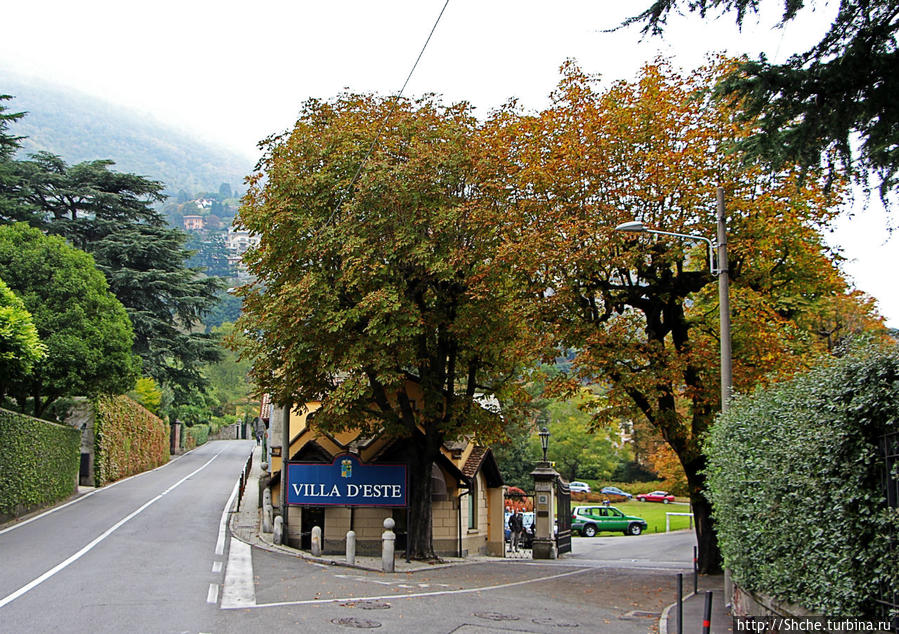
[0,115,221,398]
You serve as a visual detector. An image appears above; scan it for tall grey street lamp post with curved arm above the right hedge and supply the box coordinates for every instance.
[615,187,733,412]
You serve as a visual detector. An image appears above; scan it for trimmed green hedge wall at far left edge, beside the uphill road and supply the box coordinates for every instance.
[0,410,81,521]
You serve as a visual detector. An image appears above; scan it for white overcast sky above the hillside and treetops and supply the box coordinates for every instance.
[0,0,899,327]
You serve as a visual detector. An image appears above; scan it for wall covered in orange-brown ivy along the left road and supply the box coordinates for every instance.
[94,396,170,486]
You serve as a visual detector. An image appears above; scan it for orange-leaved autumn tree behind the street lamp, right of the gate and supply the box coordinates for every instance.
[491,63,877,572]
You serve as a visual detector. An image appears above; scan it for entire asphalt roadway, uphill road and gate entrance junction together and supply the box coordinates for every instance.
[0,441,695,634]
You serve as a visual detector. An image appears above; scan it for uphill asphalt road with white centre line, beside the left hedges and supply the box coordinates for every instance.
[0,441,253,633]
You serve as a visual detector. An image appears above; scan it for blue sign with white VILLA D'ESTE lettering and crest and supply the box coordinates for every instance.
[287,454,406,506]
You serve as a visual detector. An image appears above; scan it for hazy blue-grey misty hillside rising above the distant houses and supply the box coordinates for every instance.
[0,71,253,194]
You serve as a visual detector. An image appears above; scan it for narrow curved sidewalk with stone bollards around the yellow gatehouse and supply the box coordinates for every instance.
[225,445,497,572]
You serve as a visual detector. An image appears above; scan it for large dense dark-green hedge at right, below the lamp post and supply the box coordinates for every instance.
[705,346,899,616]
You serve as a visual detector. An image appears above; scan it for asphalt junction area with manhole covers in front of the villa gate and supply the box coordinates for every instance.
[215,520,695,634]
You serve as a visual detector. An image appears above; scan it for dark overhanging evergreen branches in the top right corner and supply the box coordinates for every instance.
[625,0,899,198]
